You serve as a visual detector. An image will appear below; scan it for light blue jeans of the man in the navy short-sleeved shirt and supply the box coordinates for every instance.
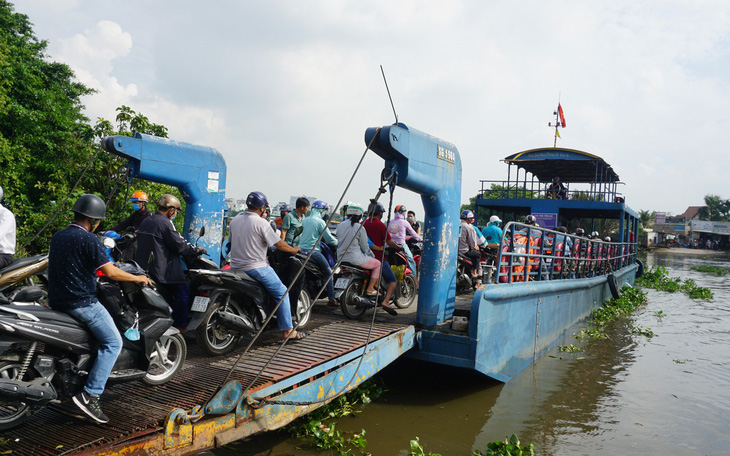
[66,300,122,396]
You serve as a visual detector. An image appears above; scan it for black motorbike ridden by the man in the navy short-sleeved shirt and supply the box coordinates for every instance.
[0,263,187,430]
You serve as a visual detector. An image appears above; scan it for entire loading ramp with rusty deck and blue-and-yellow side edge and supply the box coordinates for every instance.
[0,304,416,456]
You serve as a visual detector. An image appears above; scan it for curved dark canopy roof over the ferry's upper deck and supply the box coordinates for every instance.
[502,147,619,183]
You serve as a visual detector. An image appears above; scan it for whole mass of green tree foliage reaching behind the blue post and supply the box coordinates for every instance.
[0,0,176,256]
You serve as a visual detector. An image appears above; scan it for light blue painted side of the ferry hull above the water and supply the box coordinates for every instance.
[408,264,638,382]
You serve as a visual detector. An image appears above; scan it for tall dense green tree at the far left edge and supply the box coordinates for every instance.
[0,0,93,254]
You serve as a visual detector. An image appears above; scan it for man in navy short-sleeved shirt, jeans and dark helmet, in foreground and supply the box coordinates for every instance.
[48,194,150,423]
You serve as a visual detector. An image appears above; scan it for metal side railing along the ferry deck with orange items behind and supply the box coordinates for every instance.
[494,222,636,283]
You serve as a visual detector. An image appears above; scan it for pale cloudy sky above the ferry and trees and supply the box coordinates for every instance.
[9,0,730,216]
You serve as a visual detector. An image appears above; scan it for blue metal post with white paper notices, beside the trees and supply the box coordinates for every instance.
[101,133,228,264]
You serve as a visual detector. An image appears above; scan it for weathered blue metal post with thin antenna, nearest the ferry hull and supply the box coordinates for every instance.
[365,123,461,327]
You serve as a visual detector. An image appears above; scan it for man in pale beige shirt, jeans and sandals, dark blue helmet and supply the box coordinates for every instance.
[230,192,306,340]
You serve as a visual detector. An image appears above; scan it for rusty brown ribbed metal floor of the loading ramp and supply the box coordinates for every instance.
[0,310,406,455]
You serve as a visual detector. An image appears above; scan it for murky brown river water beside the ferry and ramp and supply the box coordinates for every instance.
[214,251,730,456]
